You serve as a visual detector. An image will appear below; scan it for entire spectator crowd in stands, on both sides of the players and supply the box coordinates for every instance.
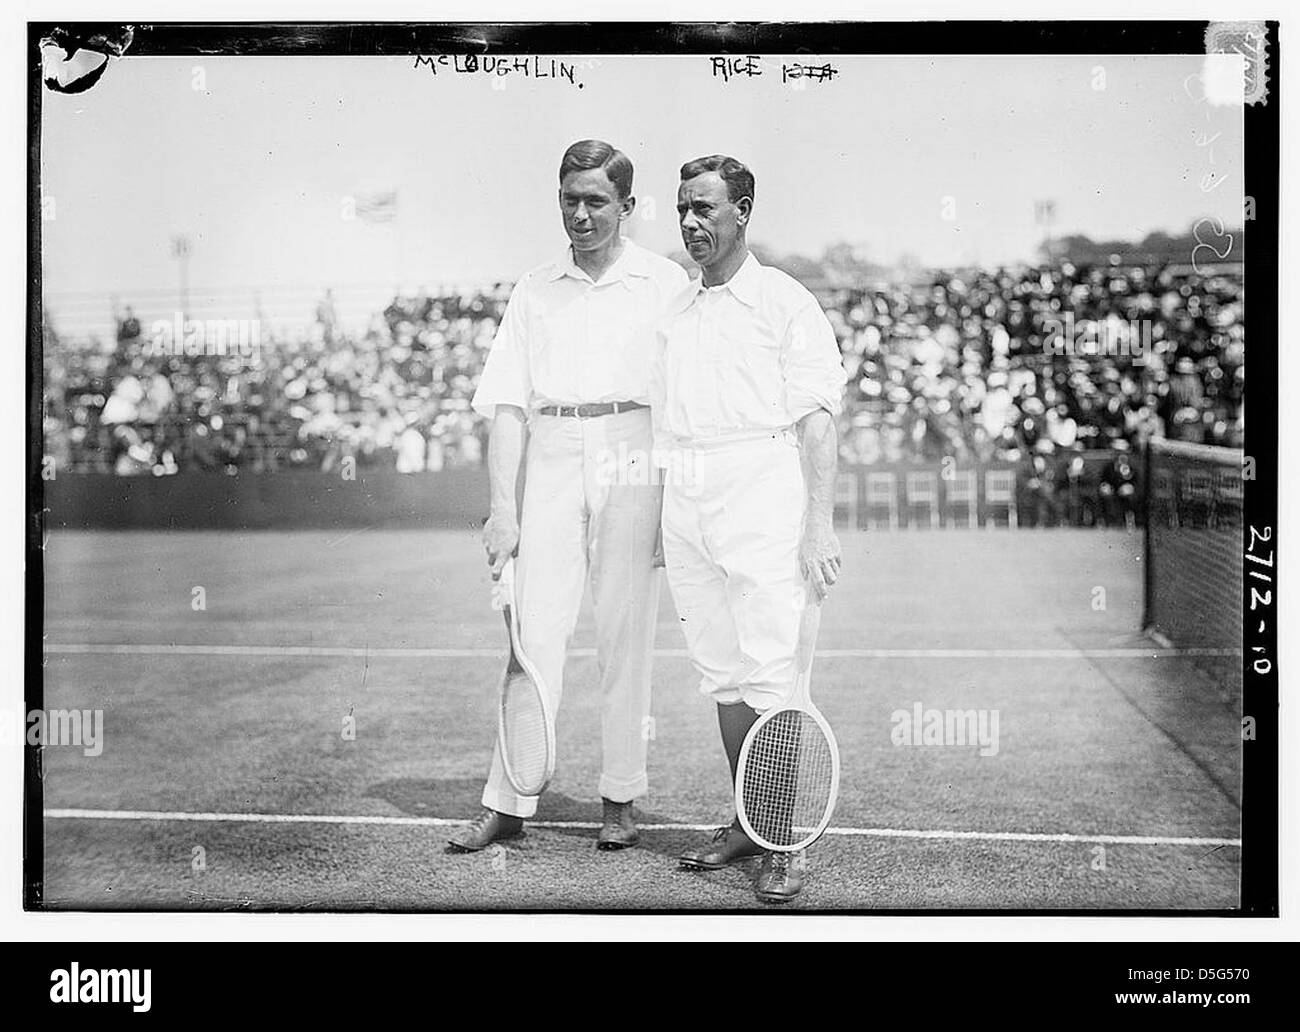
[44,263,1244,524]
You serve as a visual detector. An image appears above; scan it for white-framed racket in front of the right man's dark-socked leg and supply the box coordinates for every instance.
[736,591,840,853]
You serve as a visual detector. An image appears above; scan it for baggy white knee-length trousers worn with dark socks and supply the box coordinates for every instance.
[663,432,807,712]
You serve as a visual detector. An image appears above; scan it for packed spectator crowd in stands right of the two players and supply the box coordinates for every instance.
[827,263,1244,525]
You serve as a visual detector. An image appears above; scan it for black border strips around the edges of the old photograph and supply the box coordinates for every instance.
[22,21,1282,918]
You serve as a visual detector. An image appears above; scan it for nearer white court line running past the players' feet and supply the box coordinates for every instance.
[44,808,1242,846]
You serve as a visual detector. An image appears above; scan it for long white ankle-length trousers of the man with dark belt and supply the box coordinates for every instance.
[482,408,662,818]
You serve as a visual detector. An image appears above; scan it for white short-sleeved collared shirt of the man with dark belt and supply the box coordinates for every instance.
[473,239,688,419]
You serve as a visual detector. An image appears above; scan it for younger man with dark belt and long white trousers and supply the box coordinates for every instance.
[451,140,686,851]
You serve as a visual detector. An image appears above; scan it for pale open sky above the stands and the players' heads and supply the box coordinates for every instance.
[42,55,1243,331]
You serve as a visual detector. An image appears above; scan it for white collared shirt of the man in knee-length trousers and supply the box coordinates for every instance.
[650,255,846,450]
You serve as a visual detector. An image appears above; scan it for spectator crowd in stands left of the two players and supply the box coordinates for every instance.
[44,282,508,474]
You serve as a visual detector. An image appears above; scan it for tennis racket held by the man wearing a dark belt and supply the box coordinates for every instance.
[495,559,555,795]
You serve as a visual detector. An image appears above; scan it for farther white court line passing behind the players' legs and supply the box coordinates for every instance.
[44,642,1242,659]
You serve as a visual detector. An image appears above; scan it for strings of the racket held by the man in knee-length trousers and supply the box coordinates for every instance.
[742,710,835,846]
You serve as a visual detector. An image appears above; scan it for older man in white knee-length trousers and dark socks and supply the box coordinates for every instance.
[650,155,846,902]
